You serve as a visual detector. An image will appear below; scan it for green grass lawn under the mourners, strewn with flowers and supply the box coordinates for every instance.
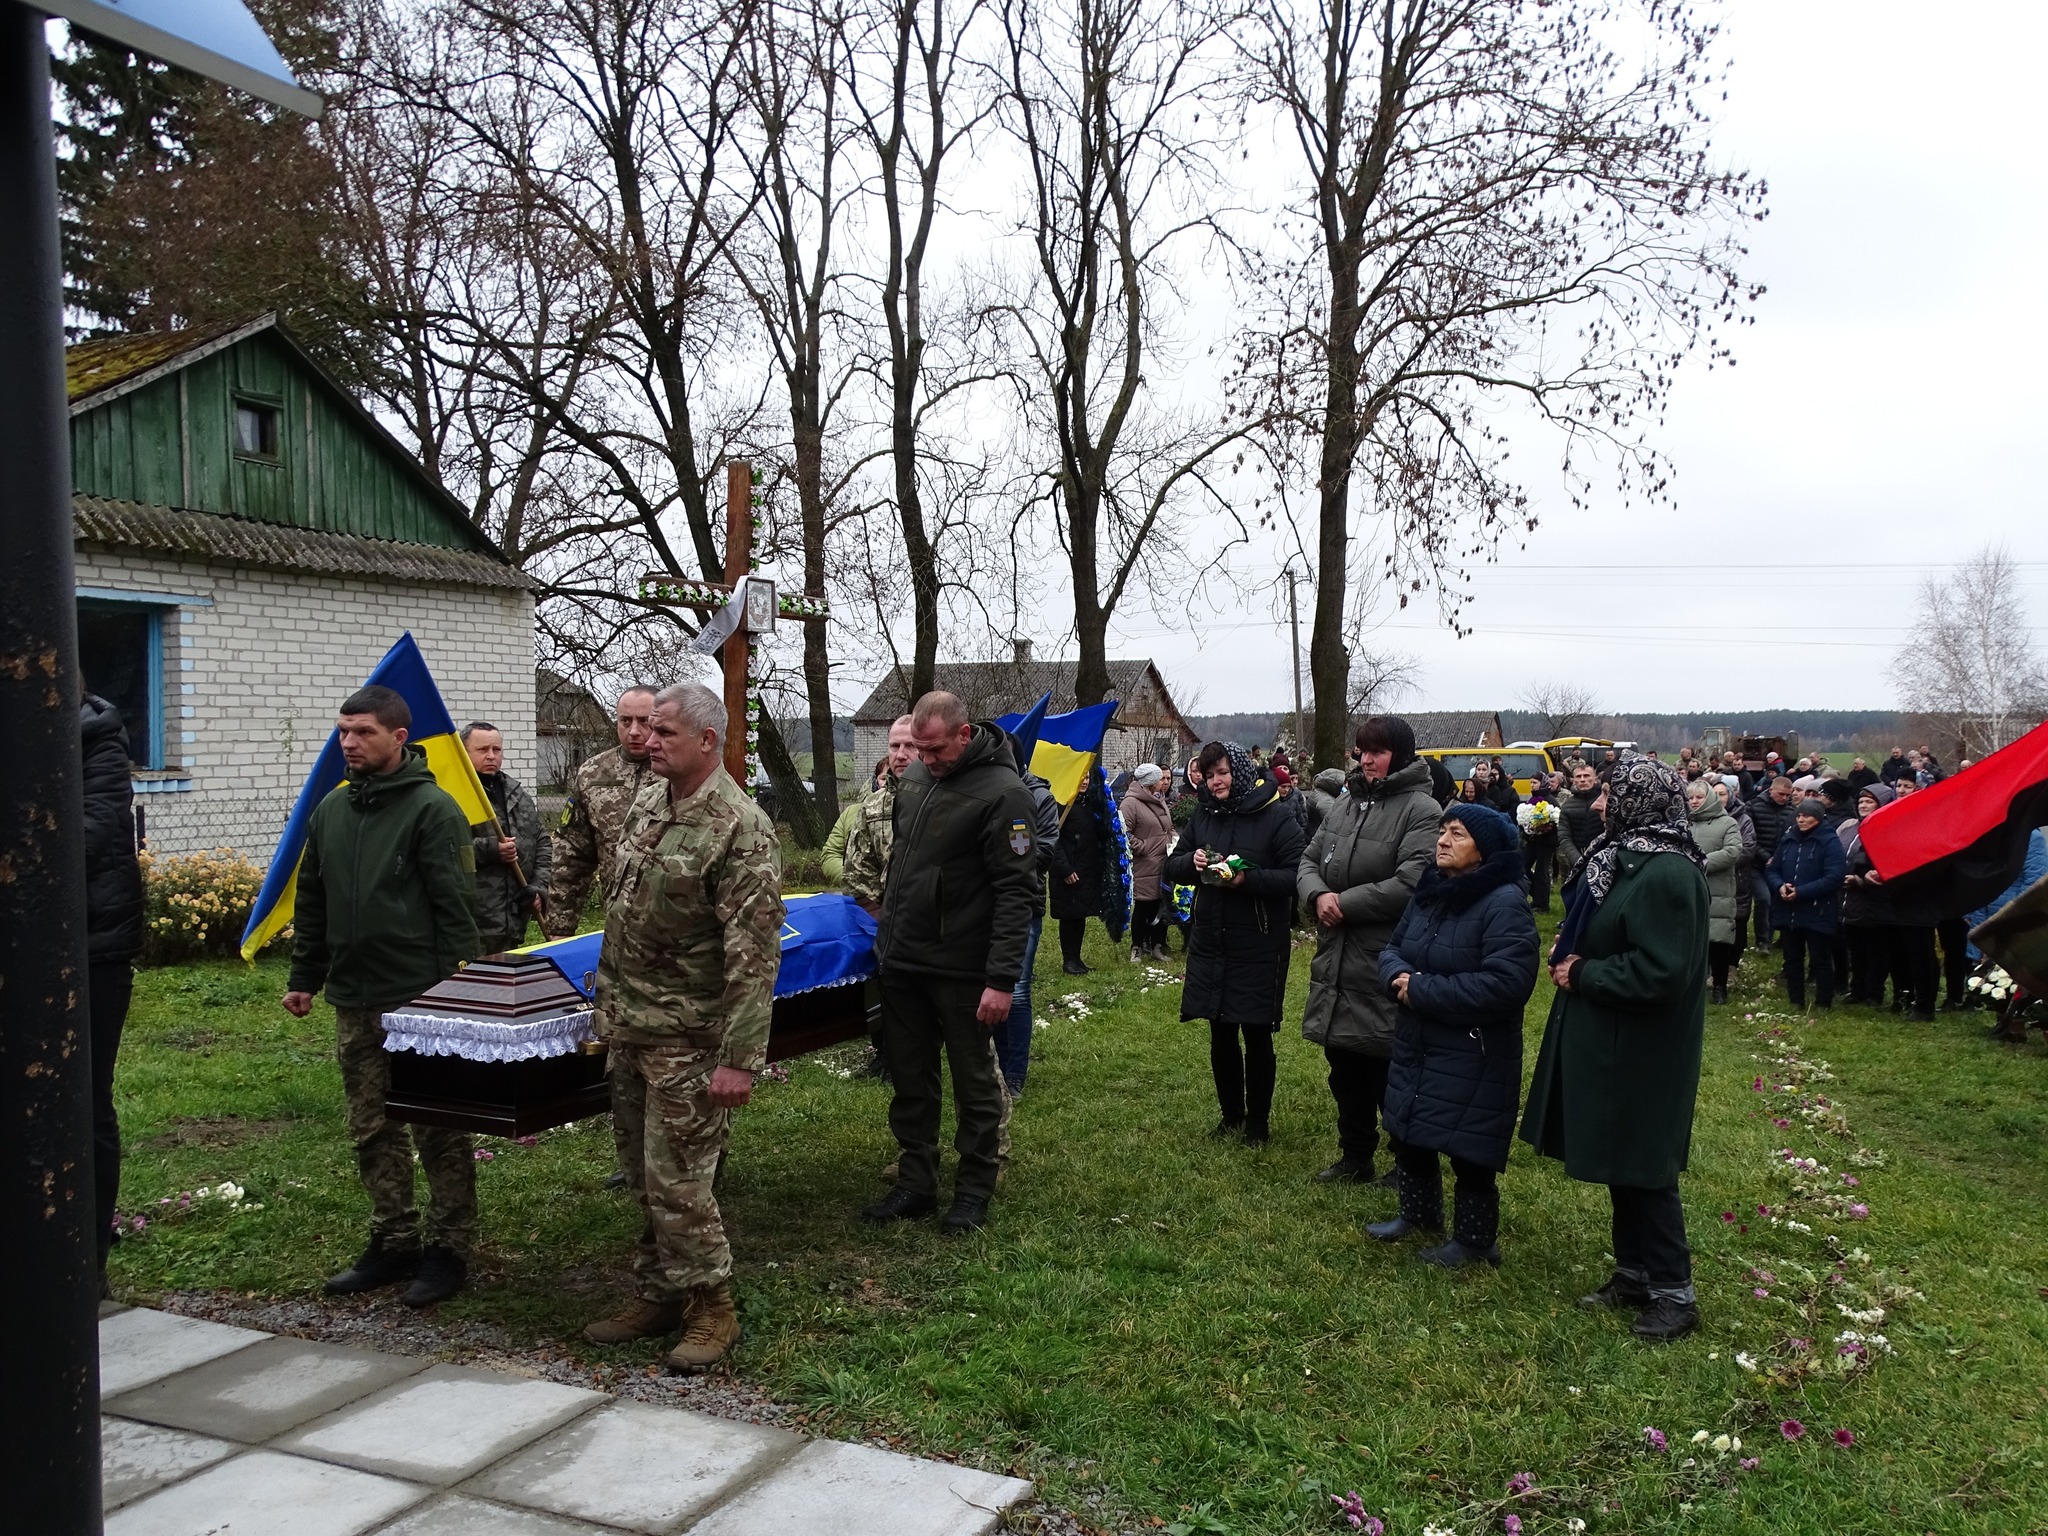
[115,936,2048,1536]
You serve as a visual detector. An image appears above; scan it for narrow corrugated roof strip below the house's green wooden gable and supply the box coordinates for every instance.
[72,496,535,590]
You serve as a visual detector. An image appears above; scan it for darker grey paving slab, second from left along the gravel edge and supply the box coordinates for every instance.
[106,1339,432,1444]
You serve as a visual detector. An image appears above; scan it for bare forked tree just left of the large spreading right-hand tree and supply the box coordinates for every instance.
[999,0,1261,705]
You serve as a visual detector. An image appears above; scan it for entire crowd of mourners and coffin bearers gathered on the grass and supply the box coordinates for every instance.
[80,684,2048,1372]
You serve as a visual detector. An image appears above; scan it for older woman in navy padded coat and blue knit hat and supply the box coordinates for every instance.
[1366,805,1536,1270]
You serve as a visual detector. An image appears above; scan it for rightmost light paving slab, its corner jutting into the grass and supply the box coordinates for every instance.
[690,1440,1030,1536]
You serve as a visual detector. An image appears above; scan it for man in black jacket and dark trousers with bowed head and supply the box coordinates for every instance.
[862,692,1042,1233]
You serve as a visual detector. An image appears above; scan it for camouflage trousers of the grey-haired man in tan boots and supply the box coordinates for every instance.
[610,1042,733,1300]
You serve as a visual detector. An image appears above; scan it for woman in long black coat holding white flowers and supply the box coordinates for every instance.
[1165,741,1305,1145]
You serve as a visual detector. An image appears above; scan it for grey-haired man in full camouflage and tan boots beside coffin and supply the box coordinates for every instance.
[584,684,782,1374]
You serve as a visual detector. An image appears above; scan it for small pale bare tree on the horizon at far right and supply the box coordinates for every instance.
[1892,545,2048,758]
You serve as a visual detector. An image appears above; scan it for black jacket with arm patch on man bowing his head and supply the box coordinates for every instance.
[874,723,1042,991]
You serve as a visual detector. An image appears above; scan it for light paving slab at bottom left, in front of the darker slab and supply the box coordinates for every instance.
[106,1450,428,1536]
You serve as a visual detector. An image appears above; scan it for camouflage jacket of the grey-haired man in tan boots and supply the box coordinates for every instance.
[596,768,782,1071]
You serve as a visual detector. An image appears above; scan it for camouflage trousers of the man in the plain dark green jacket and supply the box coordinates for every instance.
[334,1008,477,1257]
